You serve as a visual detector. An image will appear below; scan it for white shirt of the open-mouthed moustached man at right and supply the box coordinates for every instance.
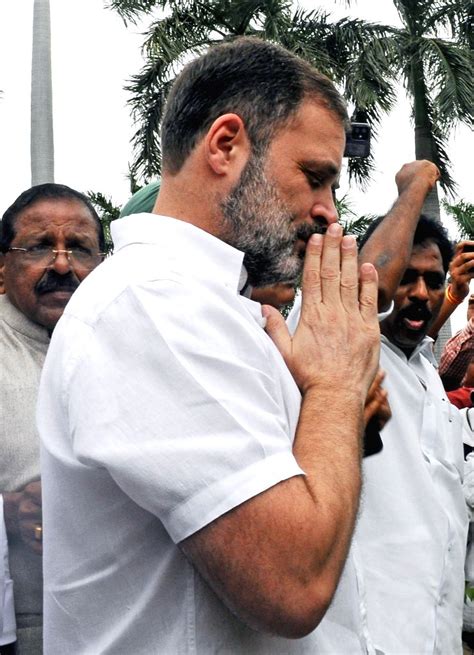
[356,336,467,655]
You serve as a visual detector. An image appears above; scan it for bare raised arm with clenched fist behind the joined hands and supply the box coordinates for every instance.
[359,160,439,311]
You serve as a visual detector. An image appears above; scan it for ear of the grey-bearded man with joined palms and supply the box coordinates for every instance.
[204,114,250,176]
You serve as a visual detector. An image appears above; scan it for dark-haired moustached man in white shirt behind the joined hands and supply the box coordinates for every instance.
[355,215,467,655]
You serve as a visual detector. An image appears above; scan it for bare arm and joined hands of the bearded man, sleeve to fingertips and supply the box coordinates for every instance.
[182,225,379,637]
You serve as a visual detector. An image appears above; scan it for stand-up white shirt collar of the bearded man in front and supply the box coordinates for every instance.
[111,213,247,293]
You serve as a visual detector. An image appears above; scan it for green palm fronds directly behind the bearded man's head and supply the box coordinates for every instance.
[108,0,395,182]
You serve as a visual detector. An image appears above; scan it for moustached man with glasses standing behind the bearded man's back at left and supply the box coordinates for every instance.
[0,184,104,655]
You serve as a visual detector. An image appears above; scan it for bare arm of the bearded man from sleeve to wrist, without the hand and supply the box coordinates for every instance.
[182,390,363,637]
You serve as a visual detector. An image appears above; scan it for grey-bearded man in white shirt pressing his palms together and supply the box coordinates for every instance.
[38,39,379,655]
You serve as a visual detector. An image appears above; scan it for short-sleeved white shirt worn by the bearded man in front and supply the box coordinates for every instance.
[38,214,368,655]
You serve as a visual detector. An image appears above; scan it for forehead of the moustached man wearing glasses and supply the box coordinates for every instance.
[14,198,98,243]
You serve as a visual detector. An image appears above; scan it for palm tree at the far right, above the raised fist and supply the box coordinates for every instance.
[347,0,474,220]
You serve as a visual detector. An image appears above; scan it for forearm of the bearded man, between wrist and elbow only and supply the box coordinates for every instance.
[294,387,365,594]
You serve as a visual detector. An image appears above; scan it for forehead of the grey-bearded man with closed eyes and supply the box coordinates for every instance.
[271,98,346,169]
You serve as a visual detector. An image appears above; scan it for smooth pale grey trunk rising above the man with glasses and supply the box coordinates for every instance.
[31,0,54,185]
